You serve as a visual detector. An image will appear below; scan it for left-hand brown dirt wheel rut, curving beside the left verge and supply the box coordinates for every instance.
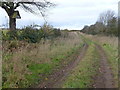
[37,44,88,88]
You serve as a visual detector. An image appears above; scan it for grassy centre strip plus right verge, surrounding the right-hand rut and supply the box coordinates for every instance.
[63,35,118,88]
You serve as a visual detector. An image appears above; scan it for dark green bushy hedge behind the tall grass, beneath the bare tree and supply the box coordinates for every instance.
[2,24,61,43]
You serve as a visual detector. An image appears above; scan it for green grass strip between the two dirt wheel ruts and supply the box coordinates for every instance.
[63,44,99,88]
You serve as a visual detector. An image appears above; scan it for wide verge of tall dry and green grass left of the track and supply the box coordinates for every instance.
[2,32,83,88]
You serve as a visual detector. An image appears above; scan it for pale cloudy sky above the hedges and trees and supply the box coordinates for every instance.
[0,0,119,29]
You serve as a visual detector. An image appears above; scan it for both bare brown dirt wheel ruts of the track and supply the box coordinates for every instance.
[37,34,115,88]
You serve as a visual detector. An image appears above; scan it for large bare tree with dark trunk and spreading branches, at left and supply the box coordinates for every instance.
[0,0,54,30]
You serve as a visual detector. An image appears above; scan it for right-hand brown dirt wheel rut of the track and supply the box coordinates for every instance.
[94,45,115,88]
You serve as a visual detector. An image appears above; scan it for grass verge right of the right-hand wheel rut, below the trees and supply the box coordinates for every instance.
[79,34,118,87]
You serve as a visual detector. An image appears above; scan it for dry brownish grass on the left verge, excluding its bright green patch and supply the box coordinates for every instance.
[2,32,83,88]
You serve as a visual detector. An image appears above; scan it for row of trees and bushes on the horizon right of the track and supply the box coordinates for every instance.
[81,10,118,36]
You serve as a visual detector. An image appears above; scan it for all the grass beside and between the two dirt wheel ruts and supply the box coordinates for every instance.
[2,32,118,88]
